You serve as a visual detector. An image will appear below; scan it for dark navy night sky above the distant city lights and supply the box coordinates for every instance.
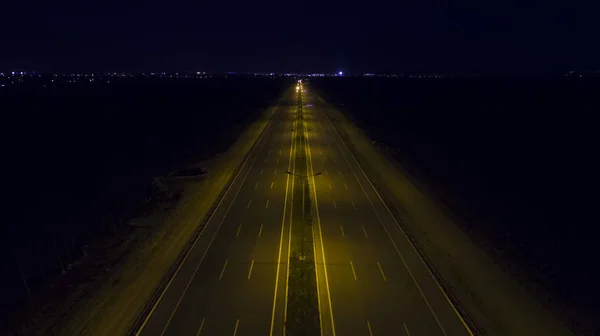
[0,0,600,73]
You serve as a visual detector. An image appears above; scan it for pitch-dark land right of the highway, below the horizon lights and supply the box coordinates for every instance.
[309,77,600,335]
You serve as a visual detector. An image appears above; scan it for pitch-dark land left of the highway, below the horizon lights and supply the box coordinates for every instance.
[0,76,286,334]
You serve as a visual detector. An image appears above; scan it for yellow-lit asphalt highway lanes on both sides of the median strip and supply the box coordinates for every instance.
[137,87,469,336]
